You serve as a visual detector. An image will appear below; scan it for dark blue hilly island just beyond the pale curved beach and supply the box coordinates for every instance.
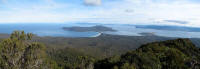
[62,25,117,32]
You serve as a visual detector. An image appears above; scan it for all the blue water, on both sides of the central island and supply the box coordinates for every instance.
[0,23,200,38]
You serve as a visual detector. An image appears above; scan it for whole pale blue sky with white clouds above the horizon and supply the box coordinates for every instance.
[0,0,200,27]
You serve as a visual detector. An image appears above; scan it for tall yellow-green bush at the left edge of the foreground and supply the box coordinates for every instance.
[0,31,57,69]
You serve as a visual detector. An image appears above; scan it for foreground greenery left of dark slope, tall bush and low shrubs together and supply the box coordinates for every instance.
[0,31,98,69]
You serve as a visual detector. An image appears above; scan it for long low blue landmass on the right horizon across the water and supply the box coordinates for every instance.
[135,25,200,32]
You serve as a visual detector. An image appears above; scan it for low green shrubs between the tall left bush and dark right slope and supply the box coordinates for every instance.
[47,48,95,69]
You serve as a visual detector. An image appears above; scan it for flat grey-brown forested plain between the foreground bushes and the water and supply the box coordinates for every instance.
[33,34,175,58]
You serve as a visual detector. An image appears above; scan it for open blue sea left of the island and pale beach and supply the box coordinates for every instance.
[0,23,99,37]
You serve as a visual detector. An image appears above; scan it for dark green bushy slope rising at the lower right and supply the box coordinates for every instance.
[95,39,200,69]
